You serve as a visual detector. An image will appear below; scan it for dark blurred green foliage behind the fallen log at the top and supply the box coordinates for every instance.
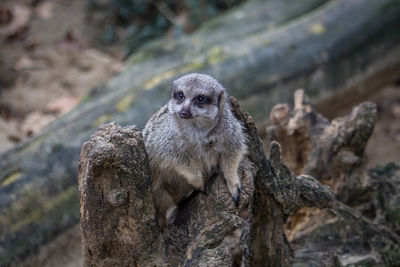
[88,0,244,54]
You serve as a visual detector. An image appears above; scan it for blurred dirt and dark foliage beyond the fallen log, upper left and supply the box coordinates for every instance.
[0,0,241,151]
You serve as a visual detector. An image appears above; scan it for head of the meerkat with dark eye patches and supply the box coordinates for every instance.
[168,73,226,126]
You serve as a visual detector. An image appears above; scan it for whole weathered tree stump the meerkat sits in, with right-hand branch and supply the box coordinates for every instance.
[79,98,333,266]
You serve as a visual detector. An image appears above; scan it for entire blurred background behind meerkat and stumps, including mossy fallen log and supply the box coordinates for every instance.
[0,0,400,266]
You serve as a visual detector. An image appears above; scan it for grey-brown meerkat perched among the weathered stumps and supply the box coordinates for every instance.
[143,73,247,231]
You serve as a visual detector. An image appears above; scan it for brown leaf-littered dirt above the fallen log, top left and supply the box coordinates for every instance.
[0,0,123,152]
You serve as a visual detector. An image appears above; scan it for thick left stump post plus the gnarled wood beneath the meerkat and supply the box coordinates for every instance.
[79,105,254,266]
